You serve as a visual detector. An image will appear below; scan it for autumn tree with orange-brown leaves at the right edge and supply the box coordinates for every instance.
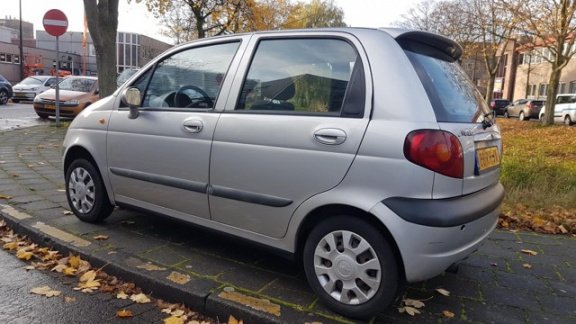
[520,0,576,125]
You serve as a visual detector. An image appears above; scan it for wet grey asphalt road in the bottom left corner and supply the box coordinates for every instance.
[0,249,166,324]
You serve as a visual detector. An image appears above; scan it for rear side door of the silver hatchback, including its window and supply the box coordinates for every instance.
[210,34,371,238]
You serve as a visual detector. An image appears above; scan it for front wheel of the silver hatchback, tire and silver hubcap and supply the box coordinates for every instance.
[66,159,114,223]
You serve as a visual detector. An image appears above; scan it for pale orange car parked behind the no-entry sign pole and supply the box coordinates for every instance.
[34,76,100,118]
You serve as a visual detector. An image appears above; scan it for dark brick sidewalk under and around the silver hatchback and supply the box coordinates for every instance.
[0,125,576,323]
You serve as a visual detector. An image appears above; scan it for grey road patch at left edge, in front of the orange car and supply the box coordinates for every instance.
[0,102,54,131]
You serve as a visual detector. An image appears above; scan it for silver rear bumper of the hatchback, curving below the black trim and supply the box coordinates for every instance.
[370,185,503,282]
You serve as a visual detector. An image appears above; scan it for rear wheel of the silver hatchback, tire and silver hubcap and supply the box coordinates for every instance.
[302,215,400,319]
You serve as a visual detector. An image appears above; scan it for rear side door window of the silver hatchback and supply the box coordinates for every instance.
[235,38,364,116]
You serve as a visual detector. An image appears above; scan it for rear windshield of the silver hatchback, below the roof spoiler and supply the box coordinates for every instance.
[405,44,490,123]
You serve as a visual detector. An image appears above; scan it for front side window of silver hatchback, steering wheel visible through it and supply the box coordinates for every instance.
[141,42,239,109]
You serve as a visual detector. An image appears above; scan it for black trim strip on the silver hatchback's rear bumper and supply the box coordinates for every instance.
[382,183,504,227]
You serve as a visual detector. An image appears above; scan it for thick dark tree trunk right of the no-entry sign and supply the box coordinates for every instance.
[84,0,118,98]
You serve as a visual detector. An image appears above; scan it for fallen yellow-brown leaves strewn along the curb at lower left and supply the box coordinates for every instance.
[0,219,216,324]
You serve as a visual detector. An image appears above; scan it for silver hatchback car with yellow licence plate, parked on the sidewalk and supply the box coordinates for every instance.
[64,28,504,318]
